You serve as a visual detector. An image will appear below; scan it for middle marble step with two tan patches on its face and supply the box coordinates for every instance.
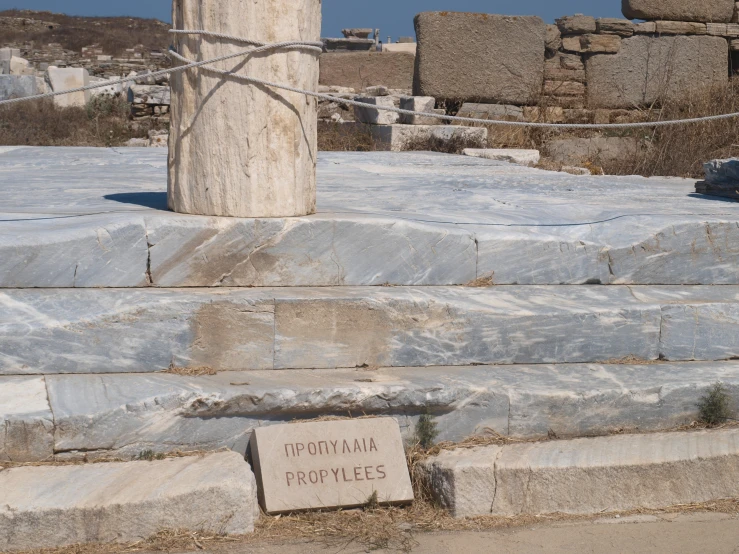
[0,285,739,375]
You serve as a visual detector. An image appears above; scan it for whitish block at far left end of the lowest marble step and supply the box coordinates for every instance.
[0,377,54,462]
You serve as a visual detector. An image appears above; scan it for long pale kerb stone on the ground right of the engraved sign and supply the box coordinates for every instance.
[418,429,739,518]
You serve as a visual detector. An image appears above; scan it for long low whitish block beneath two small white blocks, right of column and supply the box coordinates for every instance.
[362,125,488,152]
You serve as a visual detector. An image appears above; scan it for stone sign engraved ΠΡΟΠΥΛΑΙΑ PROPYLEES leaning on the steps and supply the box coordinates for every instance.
[250,418,413,514]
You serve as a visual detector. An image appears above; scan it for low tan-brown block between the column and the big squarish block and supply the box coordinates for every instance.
[320,52,416,90]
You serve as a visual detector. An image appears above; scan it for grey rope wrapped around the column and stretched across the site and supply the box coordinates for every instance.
[0,29,739,129]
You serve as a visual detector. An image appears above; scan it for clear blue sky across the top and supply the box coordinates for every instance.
[0,0,624,40]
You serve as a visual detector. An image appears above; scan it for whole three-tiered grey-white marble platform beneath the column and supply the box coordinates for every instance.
[0,147,739,461]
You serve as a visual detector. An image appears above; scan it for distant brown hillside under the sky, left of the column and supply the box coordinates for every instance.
[0,10,171,56]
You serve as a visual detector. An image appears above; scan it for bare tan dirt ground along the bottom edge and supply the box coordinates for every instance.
[166,513,739,554]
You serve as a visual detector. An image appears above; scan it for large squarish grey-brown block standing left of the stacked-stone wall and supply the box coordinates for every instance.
[413,12,546,104]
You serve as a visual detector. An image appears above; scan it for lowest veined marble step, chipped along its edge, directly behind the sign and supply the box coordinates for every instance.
[0,361,739,461]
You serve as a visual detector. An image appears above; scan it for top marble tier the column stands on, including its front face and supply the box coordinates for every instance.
[0,147,739,288]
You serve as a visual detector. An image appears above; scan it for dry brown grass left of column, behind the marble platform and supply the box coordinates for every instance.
[0,97,151,147]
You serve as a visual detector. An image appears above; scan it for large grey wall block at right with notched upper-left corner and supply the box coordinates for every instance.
[586,35,729,109]
